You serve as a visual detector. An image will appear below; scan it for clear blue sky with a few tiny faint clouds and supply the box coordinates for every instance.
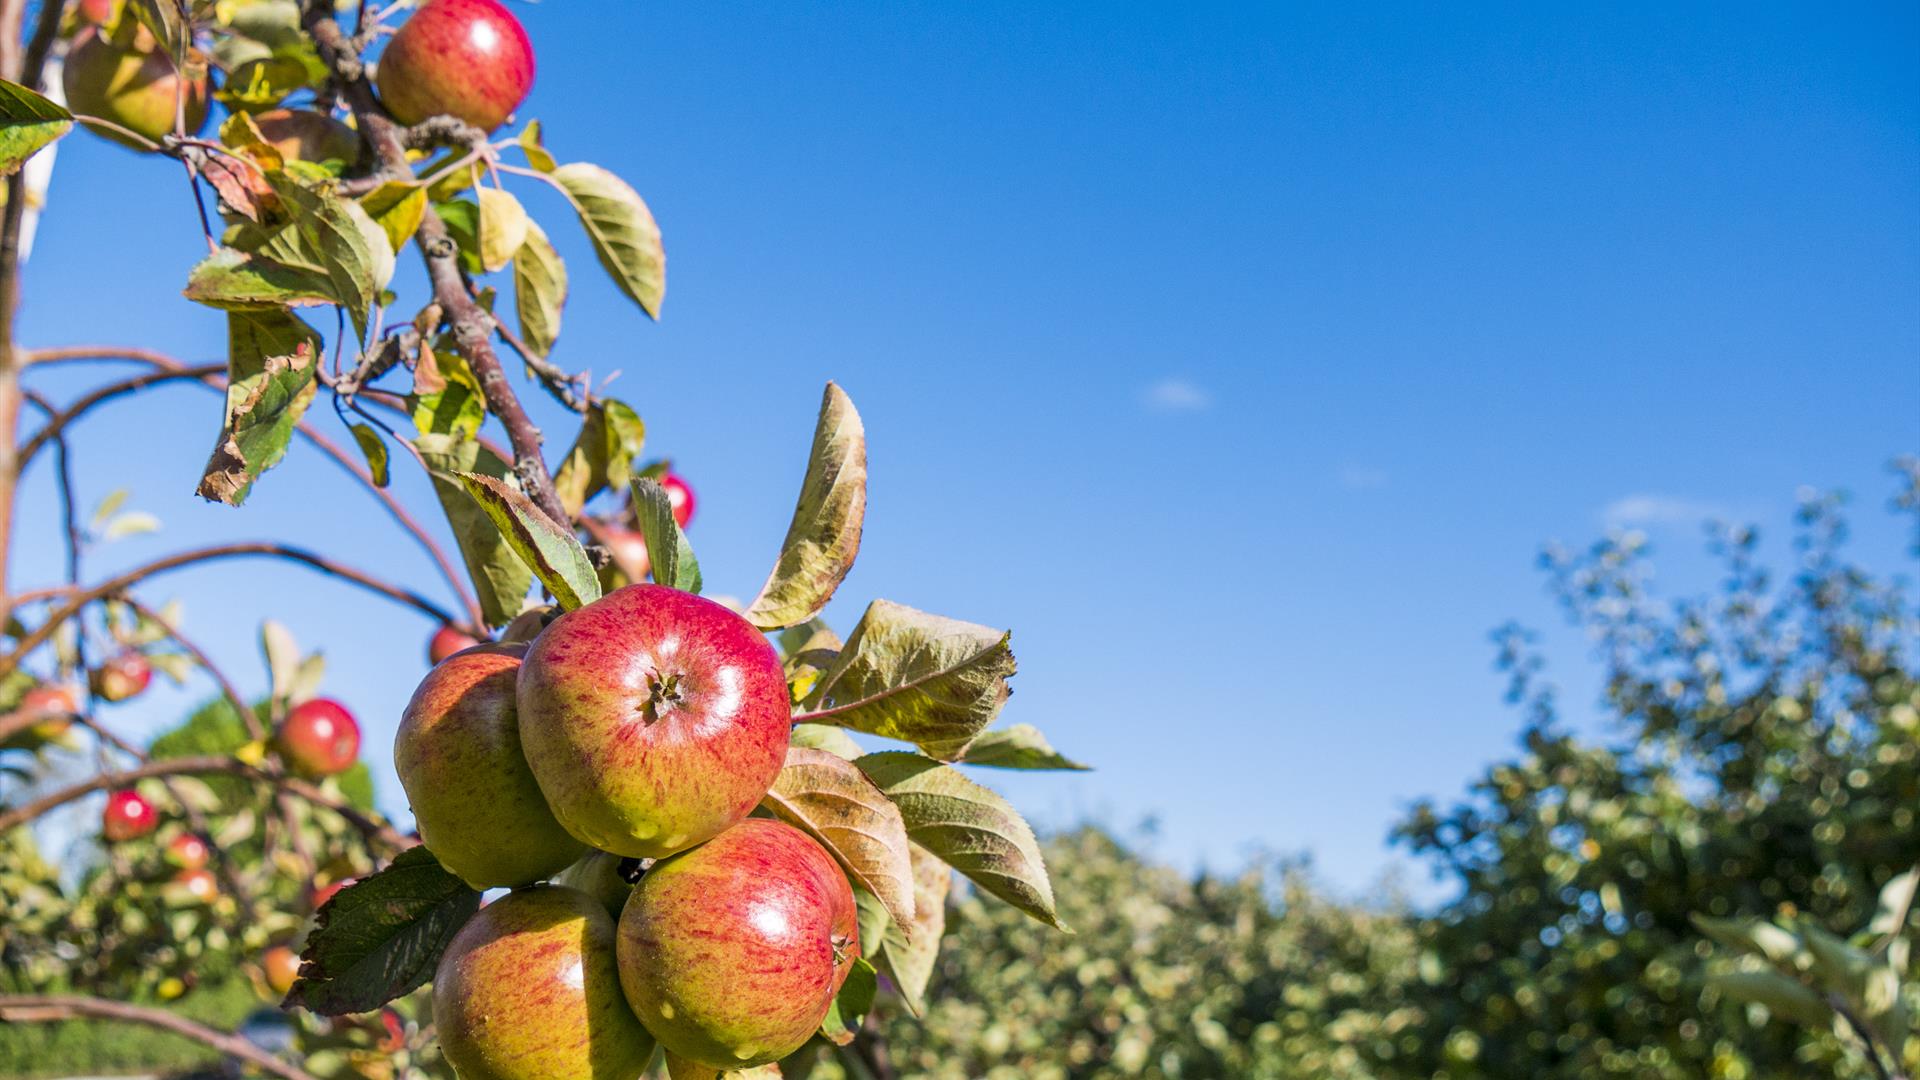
[15,2,1920,890]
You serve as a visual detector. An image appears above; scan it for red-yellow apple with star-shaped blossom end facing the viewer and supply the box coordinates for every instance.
[518,584,791,859]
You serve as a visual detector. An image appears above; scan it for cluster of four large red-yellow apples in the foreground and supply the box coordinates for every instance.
[394,538,860,1080]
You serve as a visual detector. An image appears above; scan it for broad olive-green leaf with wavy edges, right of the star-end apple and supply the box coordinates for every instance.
[793,600,1016,761]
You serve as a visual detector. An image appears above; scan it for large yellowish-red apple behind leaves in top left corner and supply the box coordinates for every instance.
[61,27,207,150]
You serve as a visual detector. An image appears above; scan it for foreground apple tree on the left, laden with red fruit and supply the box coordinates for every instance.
[0,0,1075,1080]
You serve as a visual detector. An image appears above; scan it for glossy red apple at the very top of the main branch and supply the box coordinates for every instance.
[374,0,534,131]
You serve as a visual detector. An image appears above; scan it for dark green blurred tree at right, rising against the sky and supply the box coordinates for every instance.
[1400,471,1920,1078]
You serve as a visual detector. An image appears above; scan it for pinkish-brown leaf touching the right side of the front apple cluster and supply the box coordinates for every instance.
[760,746,914,928]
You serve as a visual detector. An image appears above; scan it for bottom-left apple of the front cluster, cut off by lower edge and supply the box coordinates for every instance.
[434,886,653,1080]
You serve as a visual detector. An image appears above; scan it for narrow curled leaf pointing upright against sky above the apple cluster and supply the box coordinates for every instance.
[745,382,866,630]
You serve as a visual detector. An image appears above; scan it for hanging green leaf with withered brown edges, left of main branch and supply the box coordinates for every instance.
[200,309,321,505]
